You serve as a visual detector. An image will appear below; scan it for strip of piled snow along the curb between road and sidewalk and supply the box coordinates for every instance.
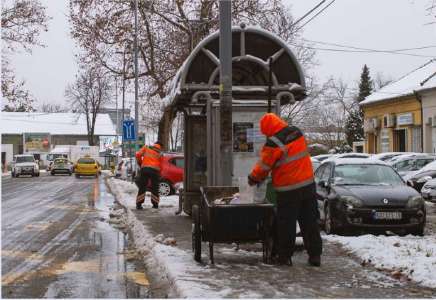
[108,178,232,298]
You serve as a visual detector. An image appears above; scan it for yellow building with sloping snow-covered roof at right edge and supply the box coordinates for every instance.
[360,59,436,153]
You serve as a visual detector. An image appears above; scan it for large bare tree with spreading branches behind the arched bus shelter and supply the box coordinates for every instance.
[70,0,314,146]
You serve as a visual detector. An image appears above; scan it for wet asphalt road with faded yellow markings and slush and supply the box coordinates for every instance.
[1,173,149,298]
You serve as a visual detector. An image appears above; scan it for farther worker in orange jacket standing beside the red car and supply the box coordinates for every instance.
[135,142,162,209]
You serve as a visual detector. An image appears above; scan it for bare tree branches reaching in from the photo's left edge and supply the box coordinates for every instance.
[1,0,49,111]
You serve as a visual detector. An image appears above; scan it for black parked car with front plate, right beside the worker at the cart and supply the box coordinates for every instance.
[315,158,426,235]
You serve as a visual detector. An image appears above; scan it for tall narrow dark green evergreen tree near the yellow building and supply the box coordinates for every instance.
[345,65,373,145]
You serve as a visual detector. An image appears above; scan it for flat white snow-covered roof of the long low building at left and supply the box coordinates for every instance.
[1,112,116,135]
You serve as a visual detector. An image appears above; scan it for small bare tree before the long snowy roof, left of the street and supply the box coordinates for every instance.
[65,66,111,145]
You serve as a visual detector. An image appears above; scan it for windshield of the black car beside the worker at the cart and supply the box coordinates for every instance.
[334,164,404,185]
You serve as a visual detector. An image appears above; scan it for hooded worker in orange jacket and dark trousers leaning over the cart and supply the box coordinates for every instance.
[248,113,322,266]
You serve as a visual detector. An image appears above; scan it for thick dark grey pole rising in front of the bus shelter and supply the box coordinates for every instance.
[218,0,233,186]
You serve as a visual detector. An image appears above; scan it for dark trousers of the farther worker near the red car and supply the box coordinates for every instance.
[135,167,160,207]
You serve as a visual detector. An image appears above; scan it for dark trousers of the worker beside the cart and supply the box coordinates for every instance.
[276,184,322,258]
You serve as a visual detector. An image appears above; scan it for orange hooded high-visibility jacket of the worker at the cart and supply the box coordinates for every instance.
[250,113,314,192]
